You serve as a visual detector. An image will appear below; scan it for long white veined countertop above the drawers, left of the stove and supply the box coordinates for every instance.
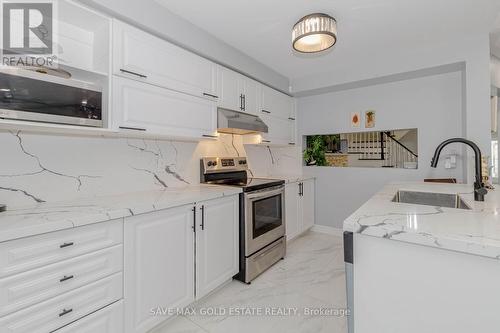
[0,185,241,242]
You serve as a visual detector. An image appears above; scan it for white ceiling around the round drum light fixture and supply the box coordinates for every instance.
[155,0,500,79]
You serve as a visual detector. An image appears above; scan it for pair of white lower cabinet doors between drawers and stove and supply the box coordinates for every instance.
[124,195,239,333]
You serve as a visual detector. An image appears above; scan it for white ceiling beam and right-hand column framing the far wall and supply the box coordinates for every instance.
[292,32,490,156]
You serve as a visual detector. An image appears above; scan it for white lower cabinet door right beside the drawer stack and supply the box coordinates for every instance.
[124,205,195,333]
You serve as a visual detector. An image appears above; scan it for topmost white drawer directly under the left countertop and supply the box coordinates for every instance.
[0,219,123,277]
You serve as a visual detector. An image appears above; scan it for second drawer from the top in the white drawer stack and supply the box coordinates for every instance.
[0,245,123,316]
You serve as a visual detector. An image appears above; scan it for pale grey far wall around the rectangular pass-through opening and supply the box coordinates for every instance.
[298,72,464,228]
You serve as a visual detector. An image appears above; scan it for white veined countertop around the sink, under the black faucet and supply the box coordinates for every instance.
[344,183,500,259]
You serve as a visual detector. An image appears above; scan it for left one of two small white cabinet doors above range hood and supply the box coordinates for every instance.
[217,66,244,112]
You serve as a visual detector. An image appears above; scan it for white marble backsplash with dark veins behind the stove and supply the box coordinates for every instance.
[0,131,301,207]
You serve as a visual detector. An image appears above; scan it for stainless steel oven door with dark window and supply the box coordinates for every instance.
[245,186,285,257]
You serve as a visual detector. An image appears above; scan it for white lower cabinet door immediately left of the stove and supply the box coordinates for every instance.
[196,195,239,299]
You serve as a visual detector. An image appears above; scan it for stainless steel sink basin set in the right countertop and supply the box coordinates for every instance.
[392,191,471,210]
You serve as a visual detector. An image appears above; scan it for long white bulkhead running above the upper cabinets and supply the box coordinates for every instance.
[79,0,289,93]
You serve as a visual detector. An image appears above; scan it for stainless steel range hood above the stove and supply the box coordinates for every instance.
[217,108,268,135]
